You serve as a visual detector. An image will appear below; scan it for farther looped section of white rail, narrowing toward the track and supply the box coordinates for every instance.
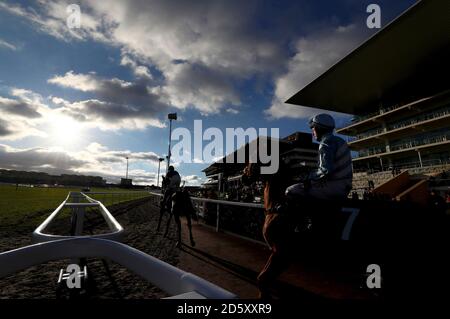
[33,192,123,243]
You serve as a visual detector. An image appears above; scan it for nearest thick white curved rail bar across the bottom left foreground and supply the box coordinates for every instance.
[0,238,237,299]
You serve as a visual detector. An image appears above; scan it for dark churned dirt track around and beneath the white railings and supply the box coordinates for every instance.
[0,200,180,299]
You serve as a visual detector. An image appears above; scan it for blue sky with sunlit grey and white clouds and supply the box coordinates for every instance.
[0,0,415,185]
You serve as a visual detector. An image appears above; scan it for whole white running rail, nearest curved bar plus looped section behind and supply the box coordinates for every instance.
[0,193,237,299]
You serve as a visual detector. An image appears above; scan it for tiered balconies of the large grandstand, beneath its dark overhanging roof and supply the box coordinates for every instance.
[337,92,450,171]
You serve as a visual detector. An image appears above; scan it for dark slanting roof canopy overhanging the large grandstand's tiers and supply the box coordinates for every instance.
[286,0,450,115]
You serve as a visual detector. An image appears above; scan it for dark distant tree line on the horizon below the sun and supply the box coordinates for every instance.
[0,169,106,187]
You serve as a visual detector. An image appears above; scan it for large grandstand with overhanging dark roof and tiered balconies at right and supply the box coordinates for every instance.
[287,0,450,178]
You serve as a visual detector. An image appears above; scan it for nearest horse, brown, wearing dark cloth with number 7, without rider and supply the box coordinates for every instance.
[242,160,449,298]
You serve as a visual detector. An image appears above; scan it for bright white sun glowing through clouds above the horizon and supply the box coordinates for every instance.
[50,115,82,147]
